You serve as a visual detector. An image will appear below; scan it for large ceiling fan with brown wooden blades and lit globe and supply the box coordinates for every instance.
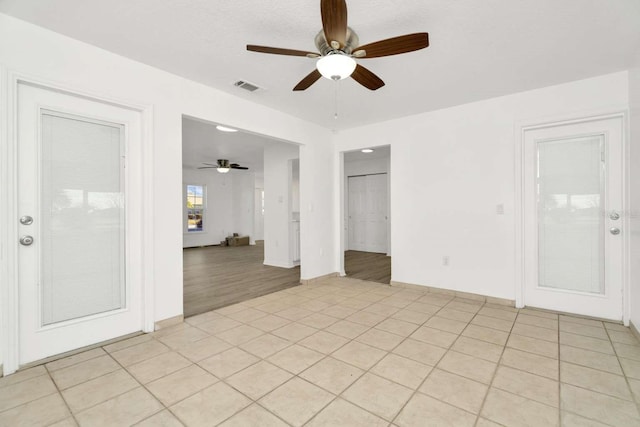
[247,0,429,91]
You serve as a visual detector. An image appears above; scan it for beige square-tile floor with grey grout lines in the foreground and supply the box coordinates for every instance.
[0,279,640,427]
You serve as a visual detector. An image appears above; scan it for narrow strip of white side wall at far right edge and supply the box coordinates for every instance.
[627,51,640,328]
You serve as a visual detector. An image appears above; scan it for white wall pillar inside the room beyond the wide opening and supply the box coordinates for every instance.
[264,144,299,267]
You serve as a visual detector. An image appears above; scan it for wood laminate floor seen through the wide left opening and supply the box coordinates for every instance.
[183,241,300,317]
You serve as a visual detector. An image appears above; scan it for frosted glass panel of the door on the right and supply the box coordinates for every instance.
[537,135,604,294]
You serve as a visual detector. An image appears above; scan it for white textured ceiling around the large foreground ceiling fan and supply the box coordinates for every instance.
[0,0,640,129]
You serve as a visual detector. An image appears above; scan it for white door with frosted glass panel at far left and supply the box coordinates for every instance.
[16,84,142,365]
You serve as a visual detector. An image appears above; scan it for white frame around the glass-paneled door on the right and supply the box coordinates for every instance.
[514,107,631,326]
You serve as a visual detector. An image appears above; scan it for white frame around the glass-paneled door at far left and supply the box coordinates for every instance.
[0,68,155,375]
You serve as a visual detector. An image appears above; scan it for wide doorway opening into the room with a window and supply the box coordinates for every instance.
[182,117,300,317]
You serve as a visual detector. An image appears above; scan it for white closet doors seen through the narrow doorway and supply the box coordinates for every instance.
[348,174,388,253]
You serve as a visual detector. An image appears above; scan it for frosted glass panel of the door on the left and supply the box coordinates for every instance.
[40,112,125,326]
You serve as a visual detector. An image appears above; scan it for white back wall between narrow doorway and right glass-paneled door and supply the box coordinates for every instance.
[334,72,628,299]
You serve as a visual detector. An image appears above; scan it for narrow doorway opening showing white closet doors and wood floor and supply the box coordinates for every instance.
[342,146,391,284]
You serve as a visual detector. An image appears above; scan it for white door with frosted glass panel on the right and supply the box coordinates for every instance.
[523,118,625,320]
